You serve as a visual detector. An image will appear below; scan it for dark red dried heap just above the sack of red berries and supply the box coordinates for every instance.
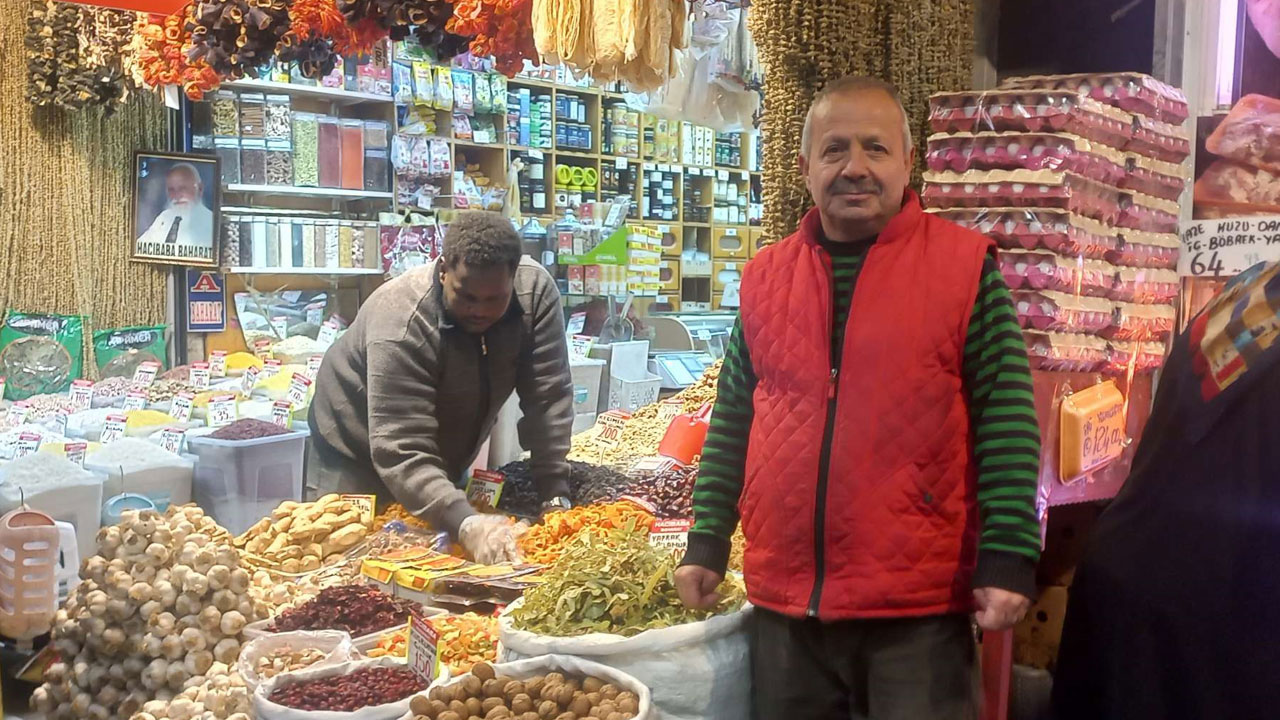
[270,585,419,638]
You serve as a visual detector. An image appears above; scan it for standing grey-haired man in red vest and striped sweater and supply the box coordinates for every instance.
[676,77,1039,720]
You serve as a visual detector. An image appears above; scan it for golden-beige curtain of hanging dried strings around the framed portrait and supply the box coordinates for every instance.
[0,0,166,366]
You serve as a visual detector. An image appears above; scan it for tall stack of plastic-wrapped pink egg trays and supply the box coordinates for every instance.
[922,73,1192,373]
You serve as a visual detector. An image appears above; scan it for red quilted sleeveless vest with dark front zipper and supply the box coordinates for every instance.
[739,191,992,620]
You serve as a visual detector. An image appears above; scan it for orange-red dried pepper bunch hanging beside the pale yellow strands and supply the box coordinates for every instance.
[445,0,538,77]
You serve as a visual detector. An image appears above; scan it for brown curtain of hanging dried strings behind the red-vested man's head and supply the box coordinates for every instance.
[748,0,973,242]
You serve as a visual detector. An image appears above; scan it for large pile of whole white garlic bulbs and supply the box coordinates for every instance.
[32,506,265,720]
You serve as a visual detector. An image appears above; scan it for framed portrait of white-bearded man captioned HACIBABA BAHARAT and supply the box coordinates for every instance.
[131,151,221,268]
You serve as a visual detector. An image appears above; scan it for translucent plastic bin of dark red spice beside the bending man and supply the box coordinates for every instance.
[187,430,310,536]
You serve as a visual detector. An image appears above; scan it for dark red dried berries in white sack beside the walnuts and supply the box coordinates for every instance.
[270,667,426,712]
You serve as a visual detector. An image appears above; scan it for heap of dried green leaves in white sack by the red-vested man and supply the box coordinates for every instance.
[512,520,744,637]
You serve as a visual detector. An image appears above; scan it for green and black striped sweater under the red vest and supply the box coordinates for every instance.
[684,242,1041,597]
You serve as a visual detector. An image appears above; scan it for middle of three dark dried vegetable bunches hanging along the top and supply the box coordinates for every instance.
[187,0,289,78]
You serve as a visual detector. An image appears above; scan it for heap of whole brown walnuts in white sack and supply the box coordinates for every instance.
[410,662,640,720]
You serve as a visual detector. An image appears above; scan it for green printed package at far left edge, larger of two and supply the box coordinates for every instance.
[0,310,84,400]
